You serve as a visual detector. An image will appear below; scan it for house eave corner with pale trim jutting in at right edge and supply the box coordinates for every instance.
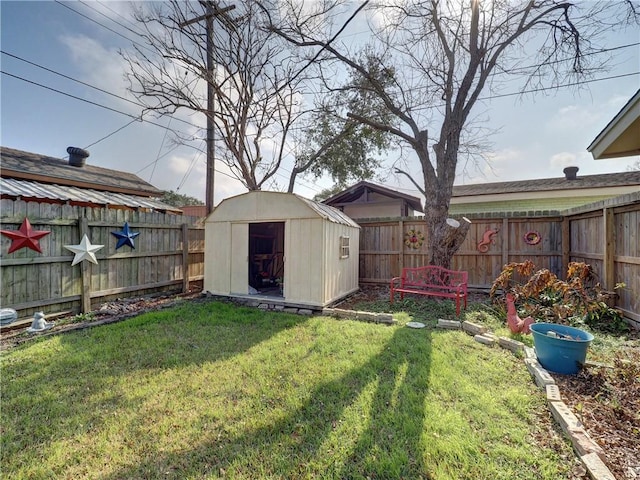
[587,90,640,160]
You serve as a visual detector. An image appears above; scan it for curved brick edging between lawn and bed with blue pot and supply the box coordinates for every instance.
[437,319,616,480]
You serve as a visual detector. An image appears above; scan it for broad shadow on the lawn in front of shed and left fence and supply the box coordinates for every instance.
[0,302,306,464]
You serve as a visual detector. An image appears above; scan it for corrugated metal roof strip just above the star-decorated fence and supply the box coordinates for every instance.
[0,178,182,213]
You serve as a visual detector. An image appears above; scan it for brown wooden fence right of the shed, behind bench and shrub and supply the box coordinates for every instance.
[358,193,640,321]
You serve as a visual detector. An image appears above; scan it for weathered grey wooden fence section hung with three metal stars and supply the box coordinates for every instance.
[0,199,204,317]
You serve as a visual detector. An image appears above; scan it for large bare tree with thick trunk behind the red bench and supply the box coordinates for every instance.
[272,0,638,266]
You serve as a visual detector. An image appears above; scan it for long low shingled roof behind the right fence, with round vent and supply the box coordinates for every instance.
[452,171,640,198]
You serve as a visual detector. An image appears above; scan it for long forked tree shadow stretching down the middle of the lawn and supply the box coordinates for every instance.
[96,318,431,480]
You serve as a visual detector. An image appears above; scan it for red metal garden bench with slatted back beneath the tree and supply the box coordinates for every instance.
[391,265,469,315]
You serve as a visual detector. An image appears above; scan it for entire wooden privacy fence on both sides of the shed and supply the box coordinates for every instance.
[0,192,640,322]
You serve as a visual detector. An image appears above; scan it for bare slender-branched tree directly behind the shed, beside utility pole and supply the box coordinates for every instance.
[122,0,306,190]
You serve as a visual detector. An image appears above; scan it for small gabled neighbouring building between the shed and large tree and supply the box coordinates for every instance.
[322,181,424,219]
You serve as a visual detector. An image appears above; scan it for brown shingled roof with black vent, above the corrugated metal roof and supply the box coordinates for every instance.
[0,147,162,197]
